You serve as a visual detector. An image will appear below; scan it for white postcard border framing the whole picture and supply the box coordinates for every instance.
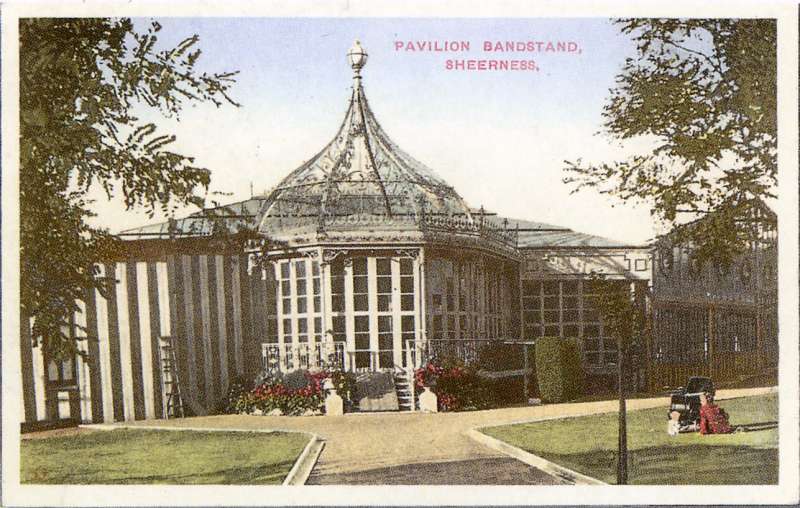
[2,0,800,506]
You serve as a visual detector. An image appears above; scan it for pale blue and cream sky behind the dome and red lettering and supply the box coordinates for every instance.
[90,18,654,243]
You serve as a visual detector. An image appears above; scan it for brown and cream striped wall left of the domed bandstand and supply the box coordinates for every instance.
[20,254,263,423]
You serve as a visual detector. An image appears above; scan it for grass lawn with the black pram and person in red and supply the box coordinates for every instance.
[482,394,778,485]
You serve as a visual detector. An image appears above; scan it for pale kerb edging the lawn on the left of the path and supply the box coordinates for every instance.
[78,423,325,485]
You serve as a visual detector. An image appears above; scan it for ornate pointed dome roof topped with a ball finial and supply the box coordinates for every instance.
[259,41,473,236]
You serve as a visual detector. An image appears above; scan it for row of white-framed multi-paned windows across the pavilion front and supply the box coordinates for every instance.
[266,257,636,366]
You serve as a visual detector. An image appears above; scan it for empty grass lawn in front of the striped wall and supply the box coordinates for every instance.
[21,429,309,484]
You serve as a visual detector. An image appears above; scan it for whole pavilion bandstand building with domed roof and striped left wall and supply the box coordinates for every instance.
[22,41,651,423]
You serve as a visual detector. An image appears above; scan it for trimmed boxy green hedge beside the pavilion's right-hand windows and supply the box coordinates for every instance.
[536,337,584,402]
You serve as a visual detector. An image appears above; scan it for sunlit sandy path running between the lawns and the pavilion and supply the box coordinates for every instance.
[126,388,775,483]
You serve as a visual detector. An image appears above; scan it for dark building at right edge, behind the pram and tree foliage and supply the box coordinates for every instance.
[649,203,778,390]
